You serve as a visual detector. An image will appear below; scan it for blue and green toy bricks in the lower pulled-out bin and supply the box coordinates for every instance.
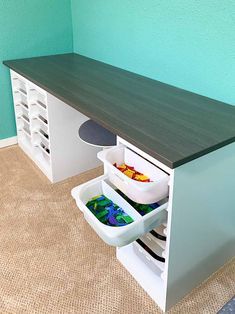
[86,194,134,227]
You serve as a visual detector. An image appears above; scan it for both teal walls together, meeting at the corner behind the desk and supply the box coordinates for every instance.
[0,0,235,139]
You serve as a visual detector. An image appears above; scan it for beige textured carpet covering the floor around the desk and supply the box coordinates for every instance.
[0,146,235,314]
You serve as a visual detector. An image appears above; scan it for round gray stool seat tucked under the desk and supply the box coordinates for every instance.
[78,120,116,147]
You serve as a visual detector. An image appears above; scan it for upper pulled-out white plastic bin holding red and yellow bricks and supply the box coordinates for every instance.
[98,145,169,204]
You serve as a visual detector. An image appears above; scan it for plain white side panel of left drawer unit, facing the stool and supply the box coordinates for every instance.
[47,93,101,182]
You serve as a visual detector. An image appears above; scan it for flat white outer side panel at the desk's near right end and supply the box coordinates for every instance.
[166,143,235,310]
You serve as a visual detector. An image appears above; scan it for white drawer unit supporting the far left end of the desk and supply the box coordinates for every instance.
[11,70,100,182]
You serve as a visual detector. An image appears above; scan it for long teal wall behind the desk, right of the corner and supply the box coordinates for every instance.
[72,0,235,104]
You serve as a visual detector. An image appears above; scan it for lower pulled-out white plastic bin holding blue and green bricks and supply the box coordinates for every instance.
[72,175,168,247]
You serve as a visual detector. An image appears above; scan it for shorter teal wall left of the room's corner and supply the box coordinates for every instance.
[0,0,73,139]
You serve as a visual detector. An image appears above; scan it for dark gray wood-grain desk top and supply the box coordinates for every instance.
[4,53,235,168]
